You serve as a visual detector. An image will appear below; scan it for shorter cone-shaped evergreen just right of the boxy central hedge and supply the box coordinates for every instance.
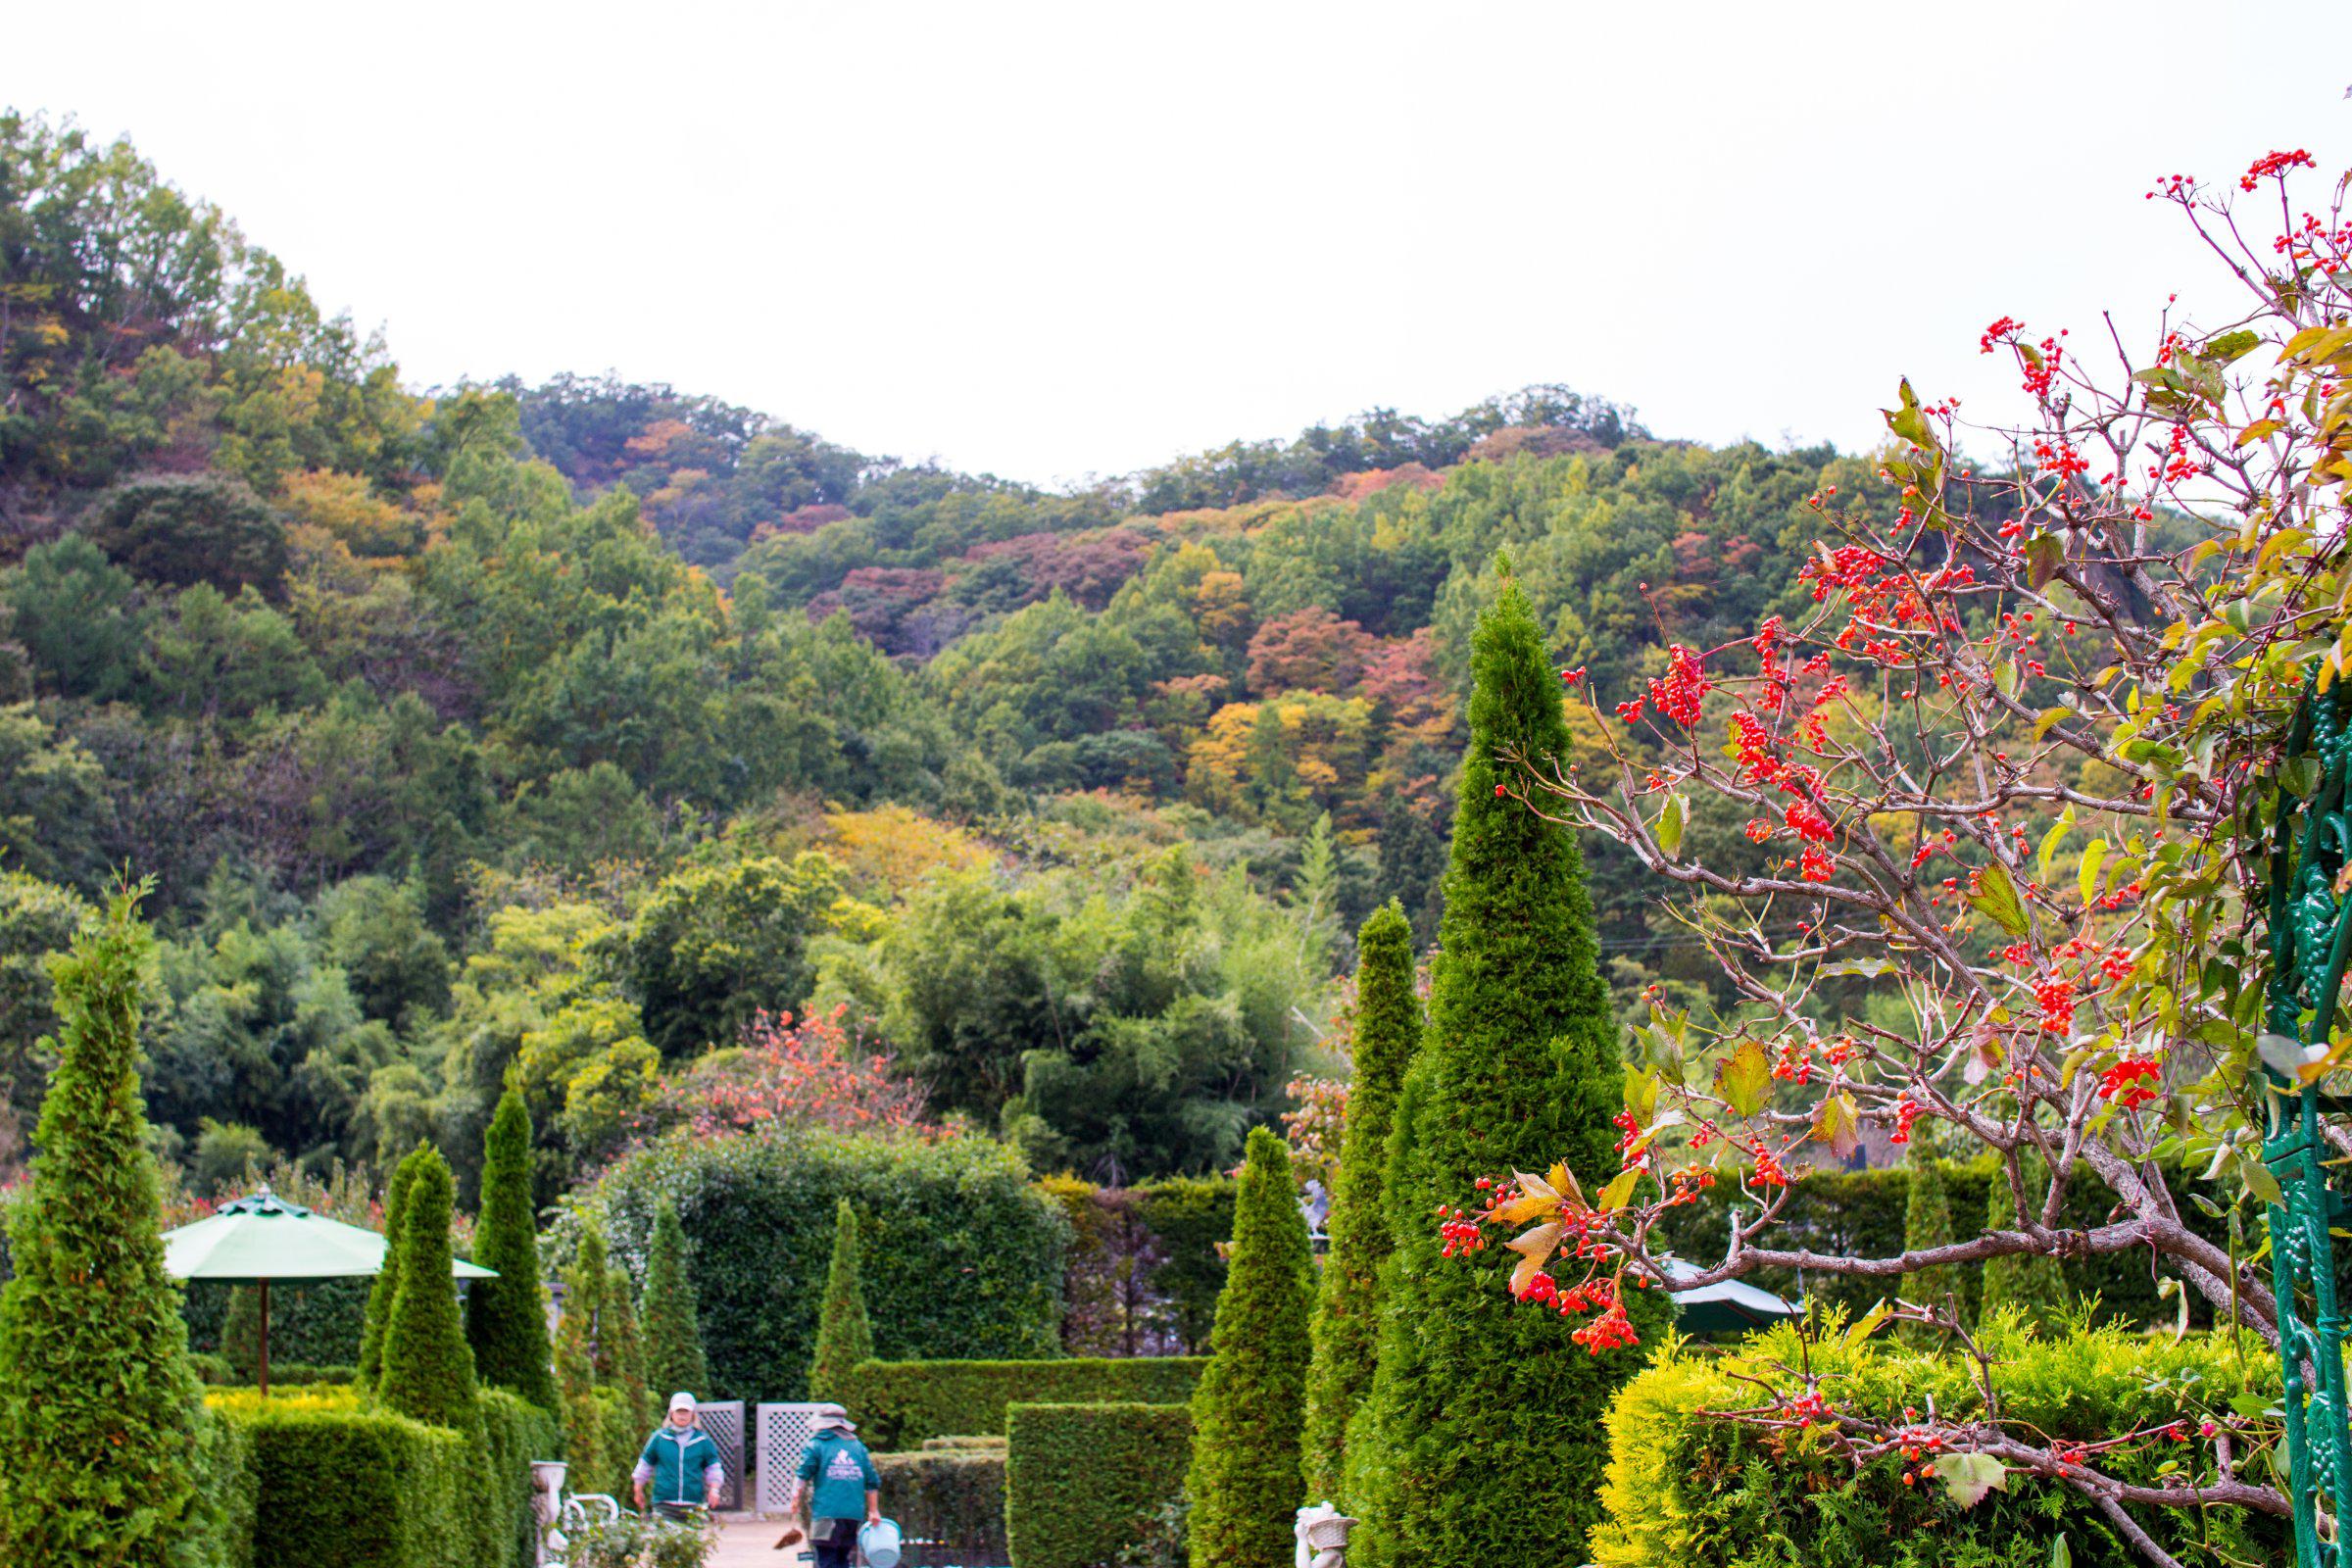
[1183,1126,1315,1568]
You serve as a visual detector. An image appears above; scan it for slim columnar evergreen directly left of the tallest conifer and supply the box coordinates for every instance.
[1305,898,1421,1502]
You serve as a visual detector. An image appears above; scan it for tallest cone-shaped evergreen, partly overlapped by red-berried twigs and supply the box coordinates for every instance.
[1348,583,1665,1568]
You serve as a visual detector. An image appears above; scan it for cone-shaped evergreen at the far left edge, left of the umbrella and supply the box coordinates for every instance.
[0,894,202,1568]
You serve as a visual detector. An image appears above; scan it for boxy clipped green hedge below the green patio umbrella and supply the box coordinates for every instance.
[205,1387,555,1568]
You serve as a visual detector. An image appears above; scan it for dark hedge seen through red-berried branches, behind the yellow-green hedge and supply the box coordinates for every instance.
[1658,1159,2230,1328]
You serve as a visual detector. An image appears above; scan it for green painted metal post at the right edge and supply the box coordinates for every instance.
[2263,684,2352,1568]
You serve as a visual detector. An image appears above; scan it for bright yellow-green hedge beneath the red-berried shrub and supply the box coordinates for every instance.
[1590,1328,2293,1568]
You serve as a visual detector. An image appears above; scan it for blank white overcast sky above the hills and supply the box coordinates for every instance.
[0,0,2352,482]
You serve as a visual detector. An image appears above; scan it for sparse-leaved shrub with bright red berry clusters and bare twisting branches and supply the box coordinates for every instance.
[1445,151,2352,1561]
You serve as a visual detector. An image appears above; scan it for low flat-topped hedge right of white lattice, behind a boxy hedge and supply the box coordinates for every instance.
[842,1356,1209,1450]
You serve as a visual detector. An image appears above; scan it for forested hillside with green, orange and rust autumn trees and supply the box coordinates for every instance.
[0,116,1868,1190]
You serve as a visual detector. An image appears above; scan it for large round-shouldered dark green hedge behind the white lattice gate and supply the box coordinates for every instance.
[588,1133,1070,1401]
